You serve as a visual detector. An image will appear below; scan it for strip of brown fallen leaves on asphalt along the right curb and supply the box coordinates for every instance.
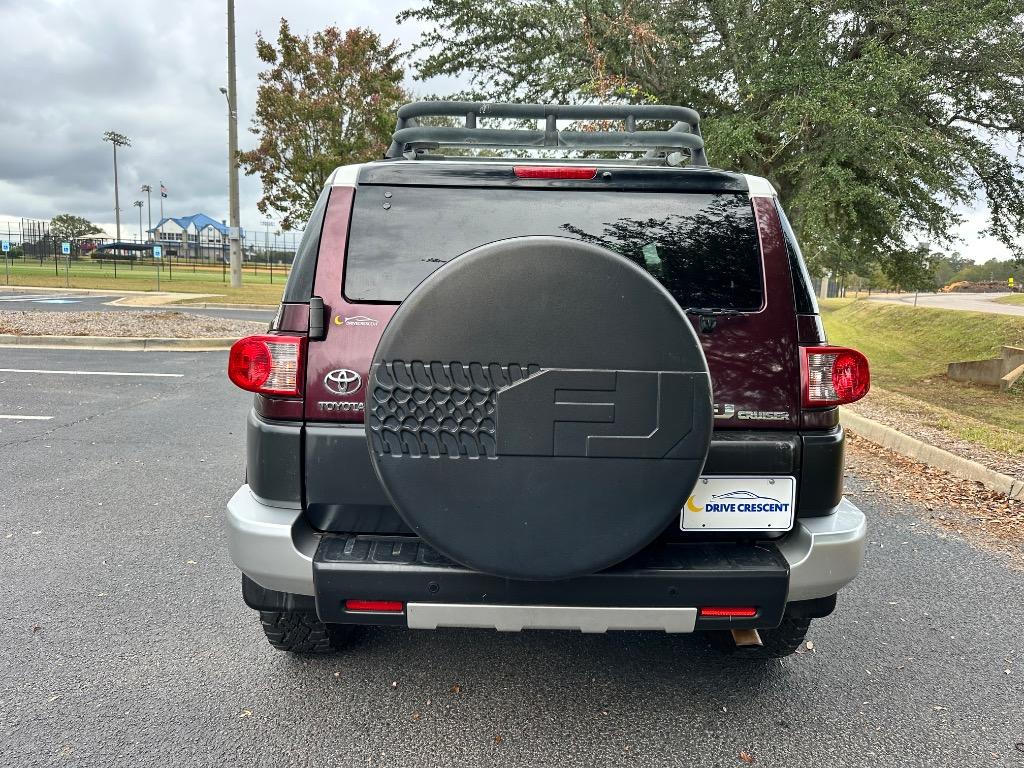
[846,434,1024,567]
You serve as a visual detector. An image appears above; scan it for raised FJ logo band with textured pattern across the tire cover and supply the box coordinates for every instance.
[370,361,702,459]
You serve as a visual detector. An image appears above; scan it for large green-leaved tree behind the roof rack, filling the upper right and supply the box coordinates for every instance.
[399,0,1024,273]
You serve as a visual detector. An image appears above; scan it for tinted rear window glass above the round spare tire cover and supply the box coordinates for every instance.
[344,186,764,310]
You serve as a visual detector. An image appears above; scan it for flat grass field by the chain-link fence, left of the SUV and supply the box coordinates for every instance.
[0,260,286,304]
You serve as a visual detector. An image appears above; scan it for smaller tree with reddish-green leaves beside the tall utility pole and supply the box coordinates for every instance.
[239,18,406,229]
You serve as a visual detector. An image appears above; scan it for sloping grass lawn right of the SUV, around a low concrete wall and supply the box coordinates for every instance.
[821,299,1024,454]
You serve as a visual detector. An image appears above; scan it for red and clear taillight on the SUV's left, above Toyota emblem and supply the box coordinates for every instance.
[227,336,304,397]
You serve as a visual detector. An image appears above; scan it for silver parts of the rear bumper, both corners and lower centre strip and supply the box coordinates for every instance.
[227,485,866,618]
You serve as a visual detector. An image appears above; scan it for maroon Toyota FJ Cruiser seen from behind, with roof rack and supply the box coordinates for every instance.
[227,101,868,656]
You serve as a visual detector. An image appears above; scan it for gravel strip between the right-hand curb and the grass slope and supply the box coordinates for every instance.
[844,387,1024,478]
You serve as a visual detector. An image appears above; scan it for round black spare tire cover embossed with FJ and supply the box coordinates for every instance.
[366,237,712,580]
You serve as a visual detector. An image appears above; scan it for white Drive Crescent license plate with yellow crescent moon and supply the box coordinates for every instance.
[679,475,797,530]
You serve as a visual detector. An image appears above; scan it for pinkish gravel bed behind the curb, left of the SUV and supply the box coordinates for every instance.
[0,311,266,339]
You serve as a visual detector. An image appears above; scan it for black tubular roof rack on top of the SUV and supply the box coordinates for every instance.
[384,101,708,166]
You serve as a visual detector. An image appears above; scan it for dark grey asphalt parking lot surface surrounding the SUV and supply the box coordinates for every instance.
[0,349,1024,768]
